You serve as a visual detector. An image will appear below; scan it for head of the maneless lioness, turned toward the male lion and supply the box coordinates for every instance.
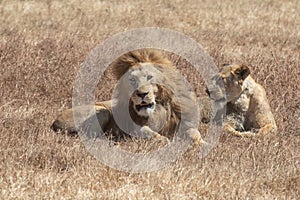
[206,65,250,102]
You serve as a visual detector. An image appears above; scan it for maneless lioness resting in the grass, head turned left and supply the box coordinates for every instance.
[207,64,277,136]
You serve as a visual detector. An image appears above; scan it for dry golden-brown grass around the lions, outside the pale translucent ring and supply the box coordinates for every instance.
[0,0,300,199]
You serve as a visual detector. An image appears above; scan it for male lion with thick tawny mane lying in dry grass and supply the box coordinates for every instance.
[52,49,202,143]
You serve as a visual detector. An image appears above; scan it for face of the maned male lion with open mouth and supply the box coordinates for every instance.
[128,63,161,117]
